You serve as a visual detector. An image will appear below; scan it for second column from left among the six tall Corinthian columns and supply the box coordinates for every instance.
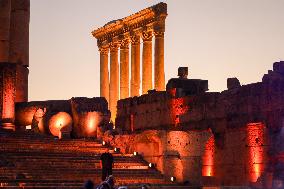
[109,43,119,122]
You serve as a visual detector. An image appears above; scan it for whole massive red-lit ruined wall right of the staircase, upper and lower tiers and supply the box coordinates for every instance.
[110,62,284,188]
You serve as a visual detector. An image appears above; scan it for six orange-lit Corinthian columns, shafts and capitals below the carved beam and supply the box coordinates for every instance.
[99,30,165,121]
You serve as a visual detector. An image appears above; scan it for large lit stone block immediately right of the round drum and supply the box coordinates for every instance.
[71,97,110,138]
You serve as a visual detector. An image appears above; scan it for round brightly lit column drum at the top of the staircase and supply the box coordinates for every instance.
[48,112,73,138]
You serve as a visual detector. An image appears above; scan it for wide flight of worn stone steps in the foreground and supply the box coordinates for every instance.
[0,130,171,188]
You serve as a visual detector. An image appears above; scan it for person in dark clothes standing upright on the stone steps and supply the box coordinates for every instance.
[100,150,113,181]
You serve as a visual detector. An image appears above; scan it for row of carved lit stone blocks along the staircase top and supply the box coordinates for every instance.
[15,97,110,137]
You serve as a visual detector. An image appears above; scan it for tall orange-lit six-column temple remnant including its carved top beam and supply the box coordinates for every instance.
[92,3,167,121]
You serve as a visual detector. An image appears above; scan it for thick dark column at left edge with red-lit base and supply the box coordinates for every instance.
[0,0,30,129]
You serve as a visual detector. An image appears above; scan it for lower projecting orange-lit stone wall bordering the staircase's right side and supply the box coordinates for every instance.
[104,130,212,185]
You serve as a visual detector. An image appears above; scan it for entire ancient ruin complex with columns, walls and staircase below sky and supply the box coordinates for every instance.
[0,0,284,189]
